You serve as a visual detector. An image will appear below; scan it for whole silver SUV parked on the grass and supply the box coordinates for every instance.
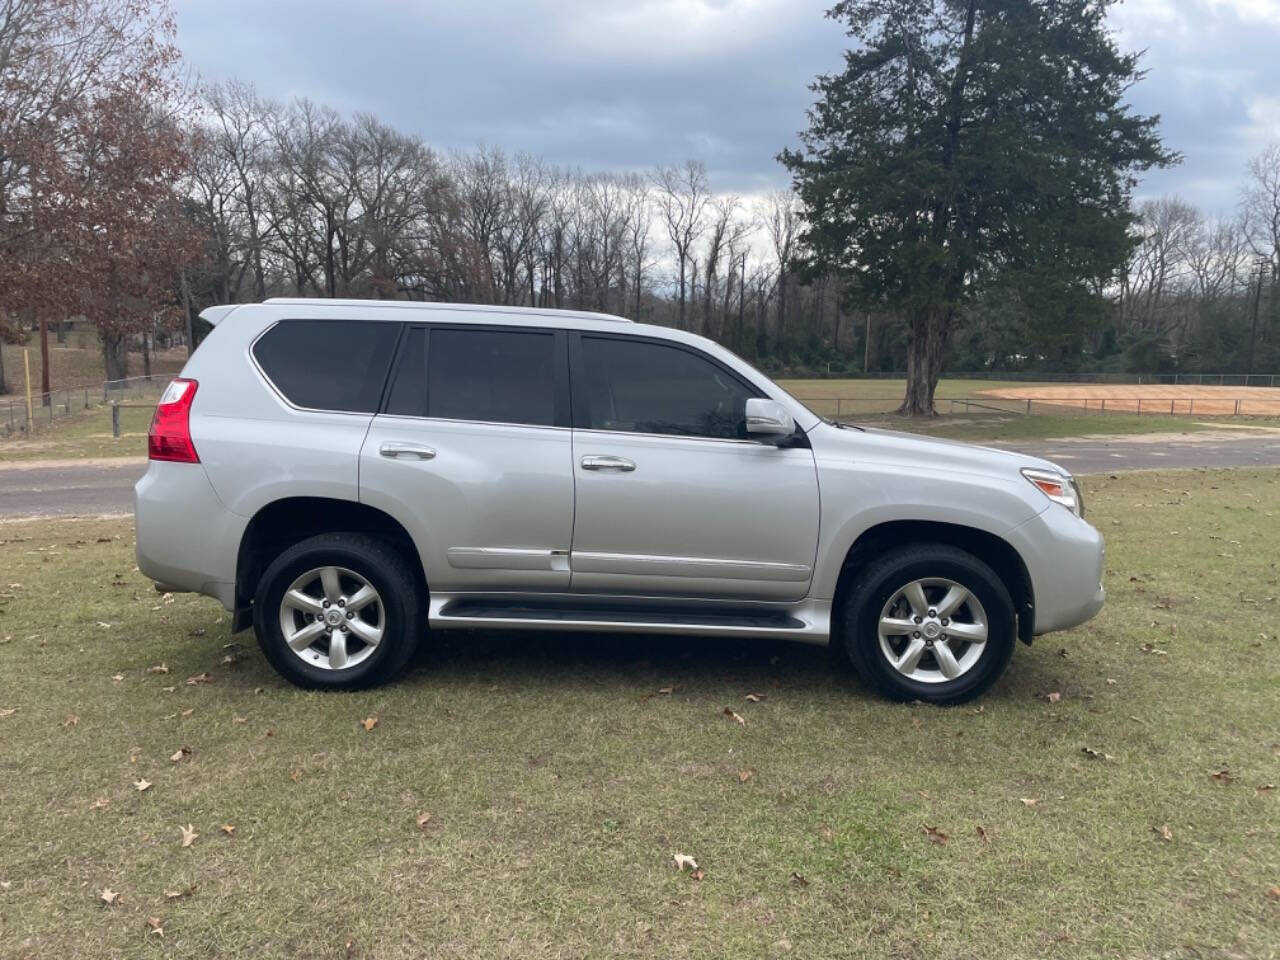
[137,300,1103,703]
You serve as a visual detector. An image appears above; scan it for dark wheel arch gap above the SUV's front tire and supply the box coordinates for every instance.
[832,520,1036,645]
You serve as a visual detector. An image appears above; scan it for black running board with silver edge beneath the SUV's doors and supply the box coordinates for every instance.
[430,596,828,643]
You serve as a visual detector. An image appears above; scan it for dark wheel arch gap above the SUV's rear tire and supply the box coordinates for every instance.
[232,497,426,632]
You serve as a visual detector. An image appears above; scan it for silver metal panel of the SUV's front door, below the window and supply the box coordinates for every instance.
[572,430,818,600]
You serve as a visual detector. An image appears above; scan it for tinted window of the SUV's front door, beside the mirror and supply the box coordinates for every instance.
[582,337,755,439]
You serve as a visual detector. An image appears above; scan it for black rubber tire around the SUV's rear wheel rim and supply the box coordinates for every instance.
[253,532,426,690]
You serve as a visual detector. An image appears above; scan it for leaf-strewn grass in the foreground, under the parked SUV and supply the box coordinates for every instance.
[0,470,1280,960]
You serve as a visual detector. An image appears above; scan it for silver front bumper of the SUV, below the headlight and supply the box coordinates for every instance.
[1009,506,1106,636]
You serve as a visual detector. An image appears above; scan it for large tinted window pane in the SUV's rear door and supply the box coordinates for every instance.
[426,328,556,426]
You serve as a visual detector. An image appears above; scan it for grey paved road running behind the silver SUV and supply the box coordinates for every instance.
[0,430,1280,517]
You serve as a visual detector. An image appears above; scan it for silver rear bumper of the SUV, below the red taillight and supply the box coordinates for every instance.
[133,461,248,609]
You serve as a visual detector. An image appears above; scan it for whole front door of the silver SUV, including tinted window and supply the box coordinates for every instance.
[571,333,818,600]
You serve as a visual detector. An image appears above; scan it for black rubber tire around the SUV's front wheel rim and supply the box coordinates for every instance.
[837,543,1016,704]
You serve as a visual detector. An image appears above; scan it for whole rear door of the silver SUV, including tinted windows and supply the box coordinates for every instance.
[360,324,573,591]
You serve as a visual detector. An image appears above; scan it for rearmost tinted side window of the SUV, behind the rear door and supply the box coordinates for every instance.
[253,320,399,413]
